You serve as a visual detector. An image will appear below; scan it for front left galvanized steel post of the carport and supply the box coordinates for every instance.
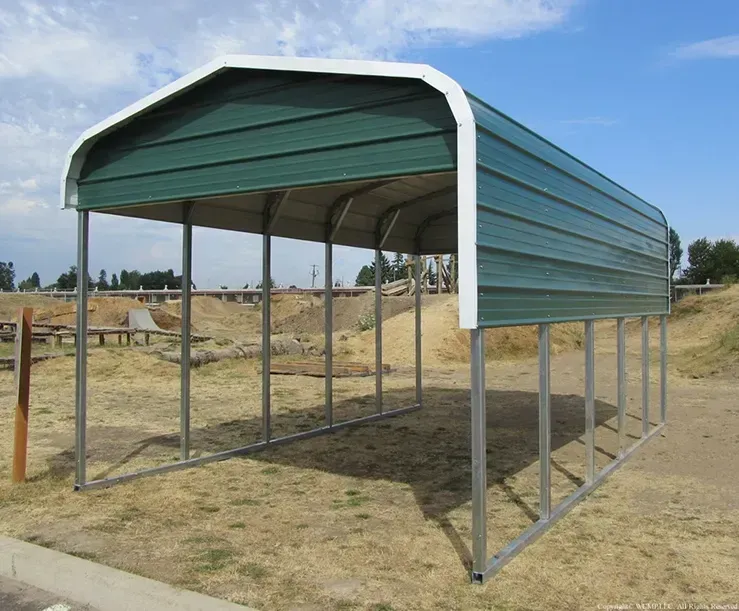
[74,211,90,489]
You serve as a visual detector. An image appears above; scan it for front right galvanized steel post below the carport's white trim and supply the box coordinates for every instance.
[470,329,488,582]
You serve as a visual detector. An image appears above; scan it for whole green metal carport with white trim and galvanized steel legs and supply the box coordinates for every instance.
[62,56,669,583]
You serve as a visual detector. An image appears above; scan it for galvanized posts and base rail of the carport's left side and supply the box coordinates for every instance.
[74,192,423,498]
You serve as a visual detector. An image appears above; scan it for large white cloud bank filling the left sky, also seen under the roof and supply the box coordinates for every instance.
[0,0,578,286]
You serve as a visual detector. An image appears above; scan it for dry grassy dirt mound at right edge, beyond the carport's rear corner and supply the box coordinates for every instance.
[669,286,739,377]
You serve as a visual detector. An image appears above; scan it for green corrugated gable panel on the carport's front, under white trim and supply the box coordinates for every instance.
[78,70,456,210]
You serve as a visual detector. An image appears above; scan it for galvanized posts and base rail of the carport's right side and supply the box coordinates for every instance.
[470,316,667,584]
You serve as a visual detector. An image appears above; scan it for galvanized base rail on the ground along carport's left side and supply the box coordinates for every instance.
[74,405,421,491]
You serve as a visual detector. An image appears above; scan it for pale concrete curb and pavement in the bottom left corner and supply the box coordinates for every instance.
[0,536,254,611]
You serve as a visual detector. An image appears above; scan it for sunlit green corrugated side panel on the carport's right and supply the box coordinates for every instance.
[469,96,669,327]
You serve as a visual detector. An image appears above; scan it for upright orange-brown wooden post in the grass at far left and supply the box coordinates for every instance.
[13,308,33,484]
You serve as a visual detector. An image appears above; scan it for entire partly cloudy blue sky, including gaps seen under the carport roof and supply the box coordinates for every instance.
[0,0,739,287]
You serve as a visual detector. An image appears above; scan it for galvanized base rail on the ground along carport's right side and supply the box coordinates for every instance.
[472,424,664,584]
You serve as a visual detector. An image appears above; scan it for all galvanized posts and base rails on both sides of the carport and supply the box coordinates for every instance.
[74,206,667,583]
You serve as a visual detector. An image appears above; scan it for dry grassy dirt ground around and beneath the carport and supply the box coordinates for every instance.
[0,291,739,611]
